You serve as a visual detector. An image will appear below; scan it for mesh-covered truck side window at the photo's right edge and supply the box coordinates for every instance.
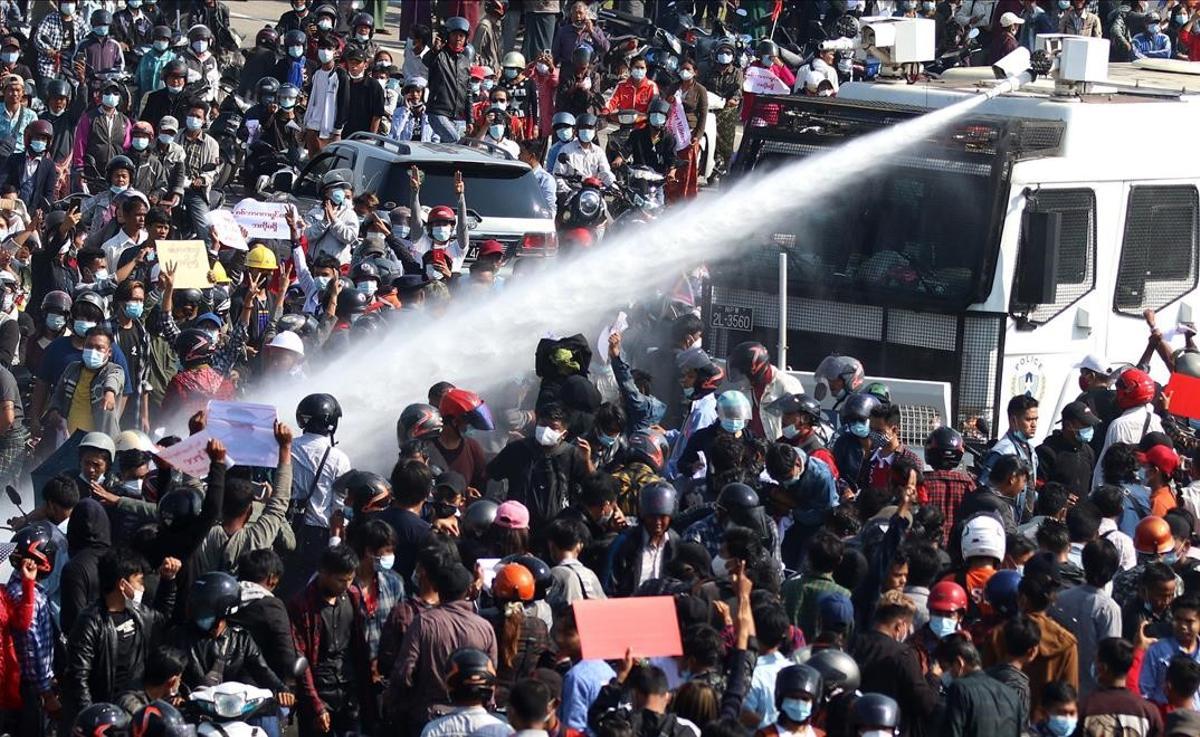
[1116,185,1200,316]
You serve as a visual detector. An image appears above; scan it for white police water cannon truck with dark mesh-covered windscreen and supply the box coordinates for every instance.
[704,18,1200,444]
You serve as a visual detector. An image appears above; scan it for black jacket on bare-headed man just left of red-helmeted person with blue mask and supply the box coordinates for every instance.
[851,630,937,737]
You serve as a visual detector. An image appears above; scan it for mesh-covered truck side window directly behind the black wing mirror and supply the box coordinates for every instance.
[1028,190,1096,323]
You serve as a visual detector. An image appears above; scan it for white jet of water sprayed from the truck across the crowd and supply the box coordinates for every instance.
[257,86,990,471]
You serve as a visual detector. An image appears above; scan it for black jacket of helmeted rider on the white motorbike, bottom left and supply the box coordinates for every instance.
[167,622,287,693]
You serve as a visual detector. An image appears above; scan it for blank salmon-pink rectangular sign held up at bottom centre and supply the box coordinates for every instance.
[574,597,683,660]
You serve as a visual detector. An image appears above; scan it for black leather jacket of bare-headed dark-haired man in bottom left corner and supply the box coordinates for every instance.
[60,602,167,724]
